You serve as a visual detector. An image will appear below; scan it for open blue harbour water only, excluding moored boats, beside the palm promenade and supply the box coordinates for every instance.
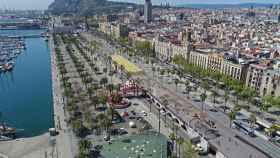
[0,30,53,137]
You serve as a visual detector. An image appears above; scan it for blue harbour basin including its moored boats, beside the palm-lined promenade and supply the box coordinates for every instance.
[0,30,53,138]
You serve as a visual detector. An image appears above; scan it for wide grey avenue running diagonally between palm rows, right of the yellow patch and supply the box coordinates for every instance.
[79,31,279,158]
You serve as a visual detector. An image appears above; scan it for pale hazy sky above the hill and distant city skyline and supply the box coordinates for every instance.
[0,0,280,9]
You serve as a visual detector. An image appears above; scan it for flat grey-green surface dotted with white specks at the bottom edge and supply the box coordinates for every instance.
[101,131,167,158]
